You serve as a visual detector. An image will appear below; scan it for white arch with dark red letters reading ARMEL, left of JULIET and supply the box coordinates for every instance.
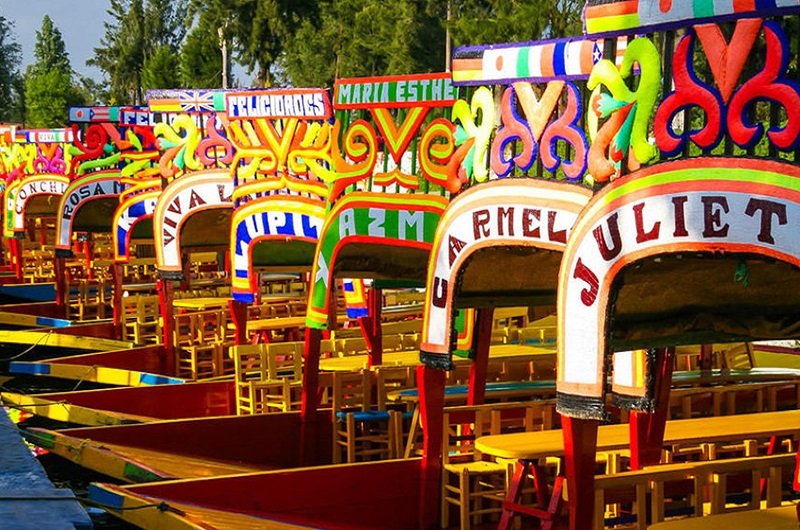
[420,179,591,369]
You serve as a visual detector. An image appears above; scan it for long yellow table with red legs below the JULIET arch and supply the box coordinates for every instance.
[475,410,800,529]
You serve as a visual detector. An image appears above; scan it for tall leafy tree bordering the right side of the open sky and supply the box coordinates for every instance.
[87,0,187,105]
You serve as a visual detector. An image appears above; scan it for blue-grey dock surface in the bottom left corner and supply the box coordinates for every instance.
[0,410,92,530]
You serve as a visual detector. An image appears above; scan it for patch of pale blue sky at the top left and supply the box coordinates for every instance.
[0,0,108,81]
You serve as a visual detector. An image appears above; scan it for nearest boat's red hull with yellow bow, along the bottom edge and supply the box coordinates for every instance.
[89,458,420,530]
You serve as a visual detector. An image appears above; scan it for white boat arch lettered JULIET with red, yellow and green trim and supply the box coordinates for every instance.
[557,158,800,419]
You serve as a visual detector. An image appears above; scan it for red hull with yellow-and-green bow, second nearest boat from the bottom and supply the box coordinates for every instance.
[24,411,332,482]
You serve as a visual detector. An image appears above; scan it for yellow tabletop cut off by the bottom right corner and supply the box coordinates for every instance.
[648,506,800,530]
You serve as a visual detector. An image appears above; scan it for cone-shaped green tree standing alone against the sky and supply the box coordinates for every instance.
[25,15,85,128]
